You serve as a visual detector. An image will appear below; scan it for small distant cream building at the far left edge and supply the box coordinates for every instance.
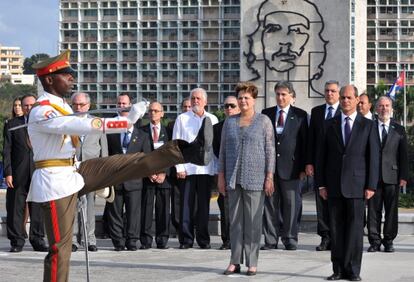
[0,45,24,77]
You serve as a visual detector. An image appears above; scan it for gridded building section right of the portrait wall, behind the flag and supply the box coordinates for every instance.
[367,0,414,91]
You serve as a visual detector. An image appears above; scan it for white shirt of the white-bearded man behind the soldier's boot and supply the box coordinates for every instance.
[172,111,218,175]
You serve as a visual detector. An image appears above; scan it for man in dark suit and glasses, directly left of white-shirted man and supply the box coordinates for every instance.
[140,102,171,249]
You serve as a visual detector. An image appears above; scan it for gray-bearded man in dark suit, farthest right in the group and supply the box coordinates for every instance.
[368,96,408,252]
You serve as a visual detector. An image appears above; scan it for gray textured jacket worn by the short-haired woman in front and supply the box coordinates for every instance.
[219,113,275,190]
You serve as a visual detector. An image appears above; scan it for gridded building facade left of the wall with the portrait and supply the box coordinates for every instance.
[60,0,240,115]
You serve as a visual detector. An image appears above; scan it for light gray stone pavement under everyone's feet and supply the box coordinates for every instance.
[0,233,414,282]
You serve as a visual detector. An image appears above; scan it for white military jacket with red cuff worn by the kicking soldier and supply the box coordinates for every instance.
[27,92,126,202]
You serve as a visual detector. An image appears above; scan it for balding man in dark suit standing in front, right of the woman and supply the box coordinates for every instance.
[315,85,379,281]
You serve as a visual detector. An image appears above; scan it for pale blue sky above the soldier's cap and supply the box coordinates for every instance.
[0,0,59,57]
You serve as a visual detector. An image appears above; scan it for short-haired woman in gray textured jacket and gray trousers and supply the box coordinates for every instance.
[218,82,275,276]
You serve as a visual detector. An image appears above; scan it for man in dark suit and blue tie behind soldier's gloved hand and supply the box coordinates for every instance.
[107,93,151,251]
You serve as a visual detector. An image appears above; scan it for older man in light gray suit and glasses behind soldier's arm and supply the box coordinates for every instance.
[71,92,108,252]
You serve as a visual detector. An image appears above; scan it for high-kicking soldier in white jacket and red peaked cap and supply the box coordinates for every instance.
[28,51,213,281]
